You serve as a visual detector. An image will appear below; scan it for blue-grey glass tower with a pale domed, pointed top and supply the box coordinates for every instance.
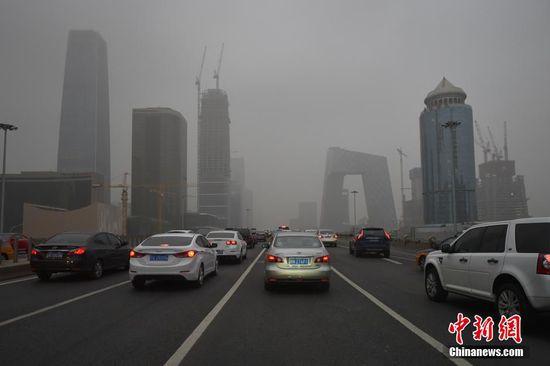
[420,78,477,224]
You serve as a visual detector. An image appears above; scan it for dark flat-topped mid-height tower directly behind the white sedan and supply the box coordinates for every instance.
[130,108,187,234]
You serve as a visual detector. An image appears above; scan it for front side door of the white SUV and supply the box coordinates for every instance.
[439,228,485,294]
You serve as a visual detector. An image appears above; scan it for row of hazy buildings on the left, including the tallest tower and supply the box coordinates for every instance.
[4,30,252,237]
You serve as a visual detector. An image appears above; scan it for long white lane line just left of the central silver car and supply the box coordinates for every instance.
[164,249,265,366]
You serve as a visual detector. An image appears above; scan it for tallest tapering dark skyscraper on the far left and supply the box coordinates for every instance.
[57,30,111,202]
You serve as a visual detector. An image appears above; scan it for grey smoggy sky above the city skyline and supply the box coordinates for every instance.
[0,0,550,227]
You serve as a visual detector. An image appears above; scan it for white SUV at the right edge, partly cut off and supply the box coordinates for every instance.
[424,217,550,316]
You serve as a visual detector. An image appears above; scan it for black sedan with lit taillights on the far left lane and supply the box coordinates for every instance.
[30,232,130,281]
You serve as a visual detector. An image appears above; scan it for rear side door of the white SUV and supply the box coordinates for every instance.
[468,224,508,299]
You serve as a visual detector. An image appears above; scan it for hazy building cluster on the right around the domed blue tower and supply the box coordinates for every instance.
[401,78,529,234]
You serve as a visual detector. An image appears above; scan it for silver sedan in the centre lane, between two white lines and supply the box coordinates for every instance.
[264,232,331,290]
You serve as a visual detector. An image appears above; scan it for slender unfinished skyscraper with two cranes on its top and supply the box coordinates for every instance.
[198,89,231,225]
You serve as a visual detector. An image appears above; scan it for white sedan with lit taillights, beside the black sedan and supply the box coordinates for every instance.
[129,233,218,289]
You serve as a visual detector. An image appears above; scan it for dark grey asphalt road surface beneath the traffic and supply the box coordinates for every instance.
[0,242,550,365]
